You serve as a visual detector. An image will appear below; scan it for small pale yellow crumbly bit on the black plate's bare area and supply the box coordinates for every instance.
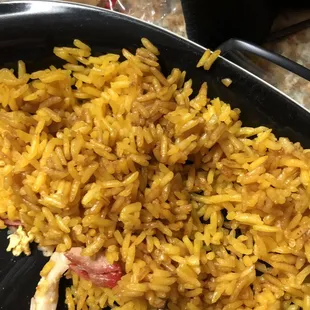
[6,226,33,256]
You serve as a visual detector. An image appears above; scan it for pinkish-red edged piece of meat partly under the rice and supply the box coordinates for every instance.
[65,247,123,288]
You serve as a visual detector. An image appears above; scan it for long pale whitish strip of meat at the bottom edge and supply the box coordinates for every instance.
[30,252,70,310]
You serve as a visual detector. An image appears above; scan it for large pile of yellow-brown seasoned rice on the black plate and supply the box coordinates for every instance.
[0,39,310,310]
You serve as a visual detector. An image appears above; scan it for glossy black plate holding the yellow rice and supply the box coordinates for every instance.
[0,1,310,310]
